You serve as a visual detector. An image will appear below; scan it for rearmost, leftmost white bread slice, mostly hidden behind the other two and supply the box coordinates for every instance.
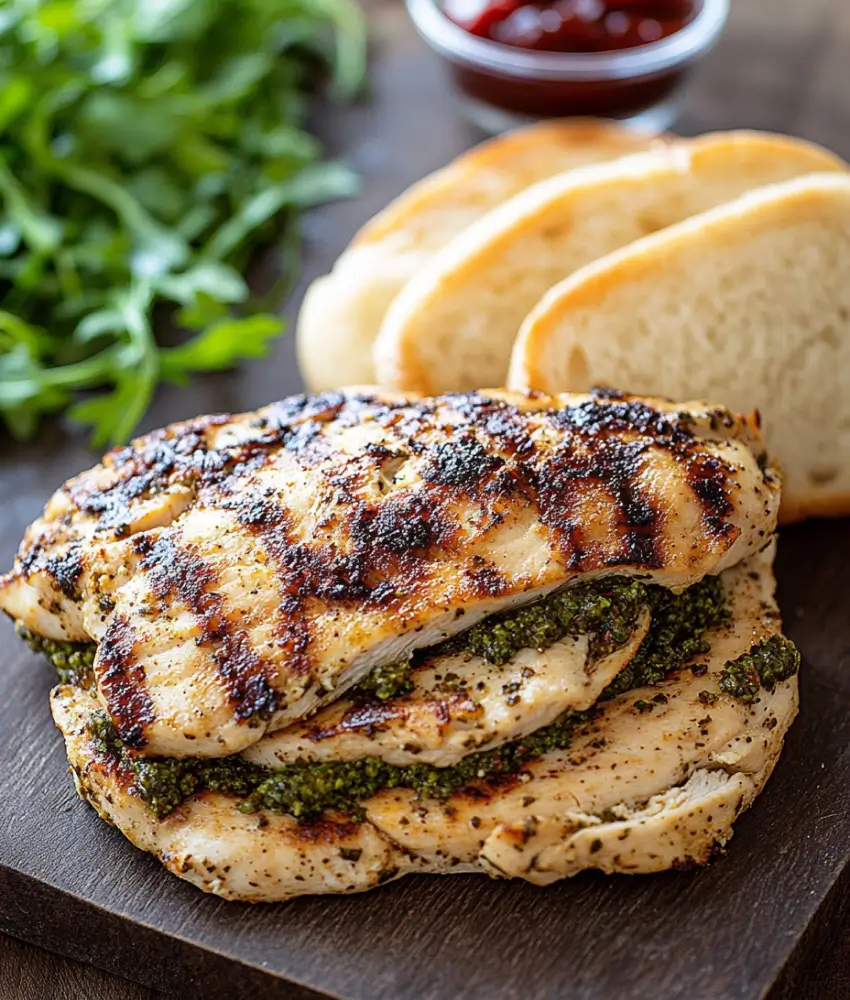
[297,119,662,390]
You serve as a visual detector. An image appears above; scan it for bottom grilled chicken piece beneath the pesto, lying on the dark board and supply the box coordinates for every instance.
[52,550,797,901]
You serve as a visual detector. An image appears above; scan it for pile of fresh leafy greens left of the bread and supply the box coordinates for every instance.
[0,0,365,446]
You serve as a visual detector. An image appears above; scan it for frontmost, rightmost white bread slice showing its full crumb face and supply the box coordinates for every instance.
[509,174,850,523]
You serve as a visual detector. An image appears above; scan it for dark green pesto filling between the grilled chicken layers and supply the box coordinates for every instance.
[18,577,799,819]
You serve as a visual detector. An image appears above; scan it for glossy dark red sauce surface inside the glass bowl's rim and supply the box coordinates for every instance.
[442,0,696,52]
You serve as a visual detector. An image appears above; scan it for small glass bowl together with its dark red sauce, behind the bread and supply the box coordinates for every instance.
[406,0,729,133]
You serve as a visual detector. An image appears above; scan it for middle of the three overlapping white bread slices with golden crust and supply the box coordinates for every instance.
[374,132,846,393]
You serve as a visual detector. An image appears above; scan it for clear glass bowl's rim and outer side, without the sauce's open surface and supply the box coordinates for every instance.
[406,0,729,133]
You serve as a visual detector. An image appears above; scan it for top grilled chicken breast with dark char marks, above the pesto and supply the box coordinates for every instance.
[0,391,779,756]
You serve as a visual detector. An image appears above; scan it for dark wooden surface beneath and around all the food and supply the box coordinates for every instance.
[0,0,850,1000]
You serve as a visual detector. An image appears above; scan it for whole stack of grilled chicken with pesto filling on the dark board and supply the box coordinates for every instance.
[0,390,798,899]
